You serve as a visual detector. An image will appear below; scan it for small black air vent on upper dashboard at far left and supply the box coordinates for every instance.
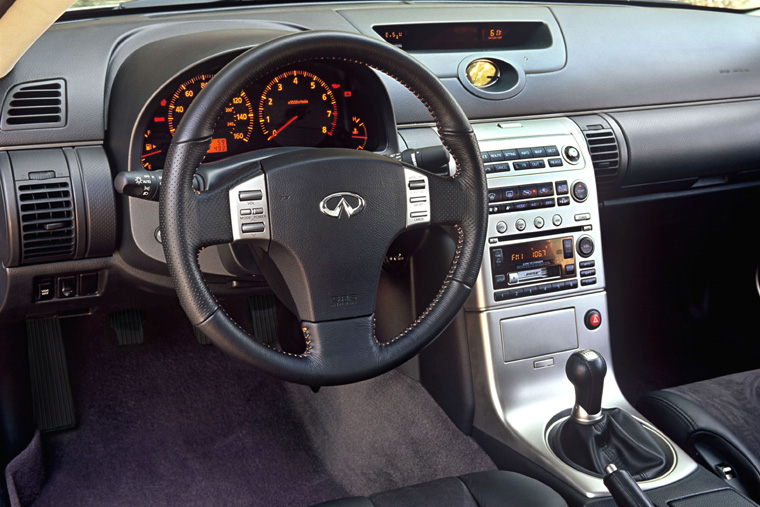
[0,79,66,130]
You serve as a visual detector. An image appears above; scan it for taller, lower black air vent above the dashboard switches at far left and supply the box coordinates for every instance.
[17,179,76,264]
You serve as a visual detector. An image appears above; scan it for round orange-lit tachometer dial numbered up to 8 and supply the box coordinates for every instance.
[259,70,338,146]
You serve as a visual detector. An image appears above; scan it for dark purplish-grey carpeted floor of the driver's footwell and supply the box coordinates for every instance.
[22,310,495,506]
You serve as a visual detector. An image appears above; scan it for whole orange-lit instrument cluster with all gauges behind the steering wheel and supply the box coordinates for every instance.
[140,62,386,170]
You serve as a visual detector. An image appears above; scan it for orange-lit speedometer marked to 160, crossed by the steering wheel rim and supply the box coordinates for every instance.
[167,74,254,153]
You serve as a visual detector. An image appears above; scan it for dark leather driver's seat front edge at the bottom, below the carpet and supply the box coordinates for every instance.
[315,470,567,507]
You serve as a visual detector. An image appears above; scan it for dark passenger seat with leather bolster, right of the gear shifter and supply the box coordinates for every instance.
[637,370,760,501]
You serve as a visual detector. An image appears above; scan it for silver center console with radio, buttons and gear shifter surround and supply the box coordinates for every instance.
[465,118,697,499]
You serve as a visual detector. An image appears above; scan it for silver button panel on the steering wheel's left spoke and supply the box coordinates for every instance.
[229,173,269,241]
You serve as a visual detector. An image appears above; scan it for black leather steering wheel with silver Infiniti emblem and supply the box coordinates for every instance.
[160,31,487,386]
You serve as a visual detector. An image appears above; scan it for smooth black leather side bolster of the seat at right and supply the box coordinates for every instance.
[636,391,760,491]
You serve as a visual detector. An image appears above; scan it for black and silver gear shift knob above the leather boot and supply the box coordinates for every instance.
[565,349,607,424]
